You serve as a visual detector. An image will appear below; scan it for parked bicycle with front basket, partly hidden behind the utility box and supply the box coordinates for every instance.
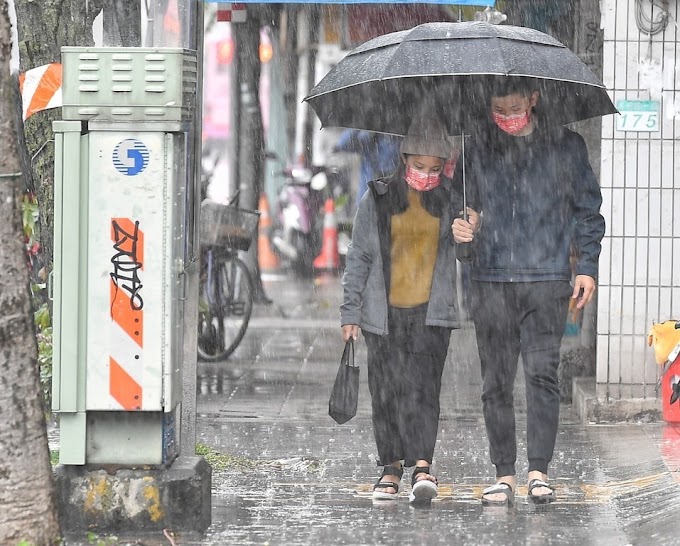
[197,200,260,362]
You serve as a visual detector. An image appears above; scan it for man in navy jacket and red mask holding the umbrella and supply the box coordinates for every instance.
[452,76,605,505]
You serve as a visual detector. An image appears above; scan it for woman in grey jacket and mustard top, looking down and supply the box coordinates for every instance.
[340,110,459,501]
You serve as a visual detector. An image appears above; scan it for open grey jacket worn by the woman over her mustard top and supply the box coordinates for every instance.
[340,174,460,335]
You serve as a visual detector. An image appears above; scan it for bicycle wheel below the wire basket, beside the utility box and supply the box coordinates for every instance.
[198,256,253,362]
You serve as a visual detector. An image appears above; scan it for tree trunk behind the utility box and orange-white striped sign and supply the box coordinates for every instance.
[15,0,104,288]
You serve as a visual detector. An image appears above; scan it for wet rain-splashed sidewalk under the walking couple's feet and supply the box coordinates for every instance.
[183,276,680,545]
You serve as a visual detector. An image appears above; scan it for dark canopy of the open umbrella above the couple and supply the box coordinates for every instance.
[304,21,617,135]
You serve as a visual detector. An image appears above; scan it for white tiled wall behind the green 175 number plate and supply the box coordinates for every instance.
[597,0,680,397]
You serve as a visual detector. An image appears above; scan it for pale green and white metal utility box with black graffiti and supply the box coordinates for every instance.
[51,48,196,464]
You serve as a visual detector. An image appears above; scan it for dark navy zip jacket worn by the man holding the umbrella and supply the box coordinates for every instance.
[452,125,605,282]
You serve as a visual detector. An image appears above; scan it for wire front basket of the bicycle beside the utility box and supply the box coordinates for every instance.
[200,200,260,250]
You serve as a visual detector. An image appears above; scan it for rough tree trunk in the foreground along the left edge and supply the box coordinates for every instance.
[0,0,60,545]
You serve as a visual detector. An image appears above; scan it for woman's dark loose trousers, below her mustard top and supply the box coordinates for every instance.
[364,304,451,466]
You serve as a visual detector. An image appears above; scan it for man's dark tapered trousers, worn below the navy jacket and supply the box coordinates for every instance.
[472,281,572,477]
